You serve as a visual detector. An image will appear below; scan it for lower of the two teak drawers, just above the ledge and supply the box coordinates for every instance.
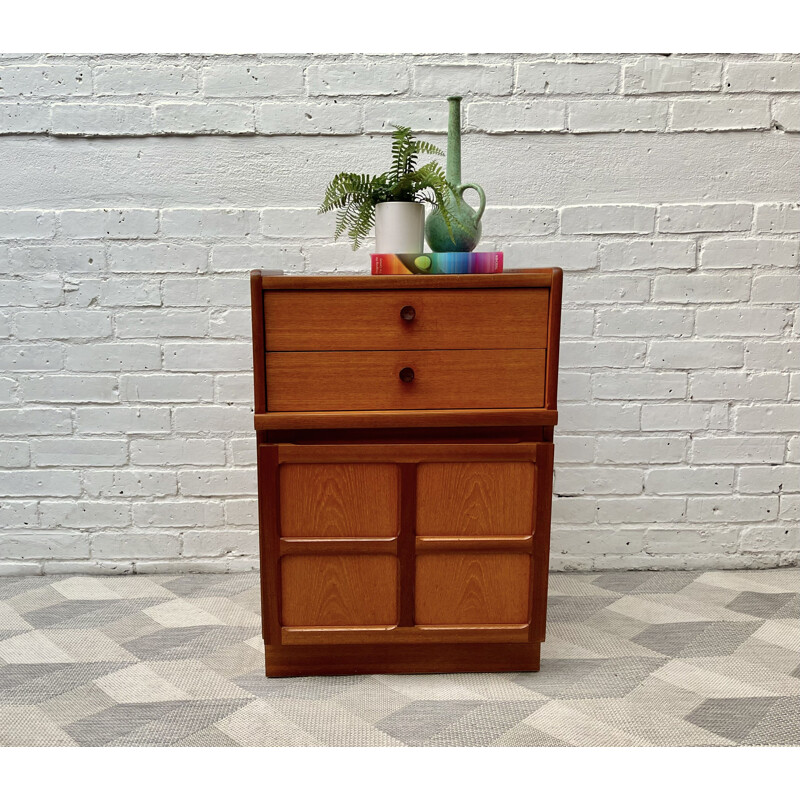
[267,350,546,411]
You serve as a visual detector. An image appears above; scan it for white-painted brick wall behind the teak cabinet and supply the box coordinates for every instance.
[0,54,800,574]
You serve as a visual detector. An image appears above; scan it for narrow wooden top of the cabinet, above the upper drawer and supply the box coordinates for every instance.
[250,267,561,291]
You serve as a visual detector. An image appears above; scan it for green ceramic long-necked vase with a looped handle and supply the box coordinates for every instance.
[425,97,486,253]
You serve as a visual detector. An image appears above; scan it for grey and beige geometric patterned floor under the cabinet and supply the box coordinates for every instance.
[0,569,800,747]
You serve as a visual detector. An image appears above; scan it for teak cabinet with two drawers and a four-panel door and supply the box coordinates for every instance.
[251,269,562,676]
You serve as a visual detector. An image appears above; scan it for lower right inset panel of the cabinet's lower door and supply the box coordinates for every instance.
[415,552,531,625]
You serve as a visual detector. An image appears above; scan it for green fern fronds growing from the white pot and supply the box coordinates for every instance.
[318,125,457,250]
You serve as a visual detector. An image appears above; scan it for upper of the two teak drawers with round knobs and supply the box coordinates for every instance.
[264,288,549,352]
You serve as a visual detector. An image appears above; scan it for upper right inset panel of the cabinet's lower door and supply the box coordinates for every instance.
[417,460,535,536]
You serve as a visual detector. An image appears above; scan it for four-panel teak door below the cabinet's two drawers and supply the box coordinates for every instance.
[259,443,552,644]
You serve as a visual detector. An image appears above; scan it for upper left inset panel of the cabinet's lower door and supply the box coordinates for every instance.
[280,463,400,538]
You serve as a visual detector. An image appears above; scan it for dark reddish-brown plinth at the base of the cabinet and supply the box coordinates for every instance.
[266,642,541,678]
